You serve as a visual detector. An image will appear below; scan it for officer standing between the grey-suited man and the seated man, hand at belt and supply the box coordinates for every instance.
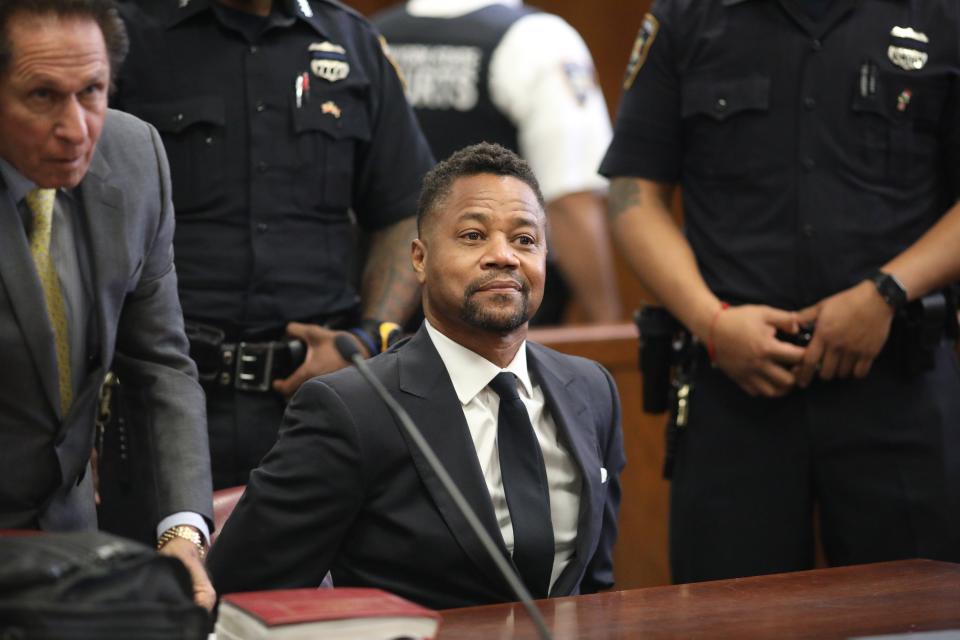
[116,0,433,488]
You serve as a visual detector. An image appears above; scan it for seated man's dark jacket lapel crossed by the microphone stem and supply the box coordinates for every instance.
[398,327,511,593]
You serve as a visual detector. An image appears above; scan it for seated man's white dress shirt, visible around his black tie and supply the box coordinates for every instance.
[424,321,581,587]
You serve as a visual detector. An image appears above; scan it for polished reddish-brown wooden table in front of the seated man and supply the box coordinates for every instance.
[439,560,960,640]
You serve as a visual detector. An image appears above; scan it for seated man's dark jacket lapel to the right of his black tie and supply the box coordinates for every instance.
[527,343,603,595]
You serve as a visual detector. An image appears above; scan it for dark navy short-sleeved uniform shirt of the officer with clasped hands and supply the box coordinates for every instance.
[601,0,960,309]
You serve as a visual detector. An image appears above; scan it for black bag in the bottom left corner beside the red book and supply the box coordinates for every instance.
[0,532,210,640]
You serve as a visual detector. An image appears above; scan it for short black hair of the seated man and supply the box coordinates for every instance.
[417,142,545,235]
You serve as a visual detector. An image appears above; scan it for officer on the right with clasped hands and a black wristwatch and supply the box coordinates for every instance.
[601,0,960,582]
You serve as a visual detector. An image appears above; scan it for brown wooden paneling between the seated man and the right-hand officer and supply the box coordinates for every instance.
[530,323,670,589]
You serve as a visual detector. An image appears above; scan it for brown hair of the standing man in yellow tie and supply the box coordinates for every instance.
[0,0,130,85]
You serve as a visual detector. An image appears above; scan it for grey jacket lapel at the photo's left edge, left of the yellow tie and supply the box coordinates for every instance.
[0,181,60,415]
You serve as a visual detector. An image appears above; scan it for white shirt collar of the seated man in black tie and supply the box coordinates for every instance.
[423,320,533,405]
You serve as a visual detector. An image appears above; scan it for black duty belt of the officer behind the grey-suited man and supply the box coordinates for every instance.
[186,322,307,393]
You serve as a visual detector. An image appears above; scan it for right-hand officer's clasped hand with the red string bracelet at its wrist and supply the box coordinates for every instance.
[712,305,804,397]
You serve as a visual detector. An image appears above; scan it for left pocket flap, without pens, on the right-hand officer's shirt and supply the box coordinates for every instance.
[681,75,770,121]
